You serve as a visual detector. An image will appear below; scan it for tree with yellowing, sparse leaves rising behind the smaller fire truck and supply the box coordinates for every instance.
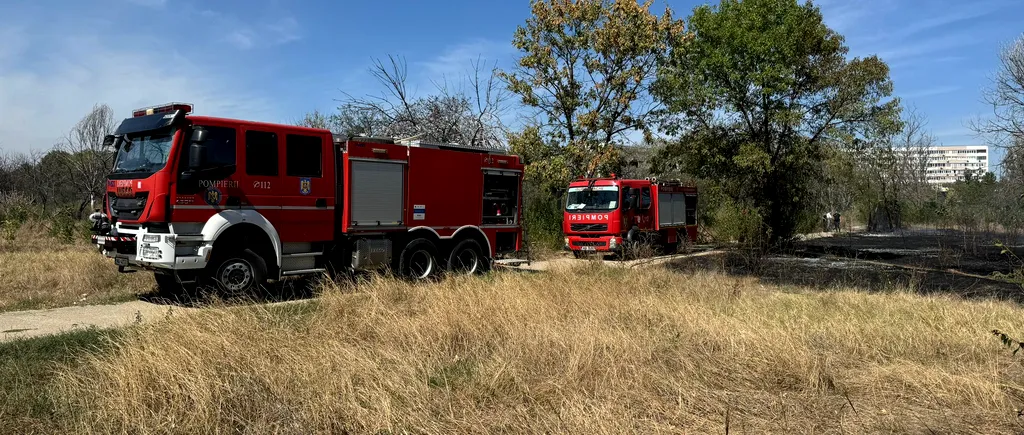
[501,0,684,184]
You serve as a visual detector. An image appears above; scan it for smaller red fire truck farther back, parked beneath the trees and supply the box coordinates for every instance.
[562,174,697,258]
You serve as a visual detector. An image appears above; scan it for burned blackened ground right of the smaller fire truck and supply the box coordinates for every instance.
[666,230,1024,302]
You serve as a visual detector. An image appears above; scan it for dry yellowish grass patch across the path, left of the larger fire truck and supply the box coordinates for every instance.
[0,240,154,311]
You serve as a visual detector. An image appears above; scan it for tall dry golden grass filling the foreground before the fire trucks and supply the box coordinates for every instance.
[57,262,1024,434]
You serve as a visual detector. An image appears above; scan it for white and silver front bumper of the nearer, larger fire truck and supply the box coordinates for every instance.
[92,223,213,270]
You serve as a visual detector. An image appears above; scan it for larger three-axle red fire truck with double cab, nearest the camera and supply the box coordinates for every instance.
[92,103,523,293]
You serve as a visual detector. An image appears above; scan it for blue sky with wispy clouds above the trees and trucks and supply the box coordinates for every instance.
[0,0,1024,167]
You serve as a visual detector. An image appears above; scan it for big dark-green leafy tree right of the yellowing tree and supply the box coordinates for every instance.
[653,0,899,244]
